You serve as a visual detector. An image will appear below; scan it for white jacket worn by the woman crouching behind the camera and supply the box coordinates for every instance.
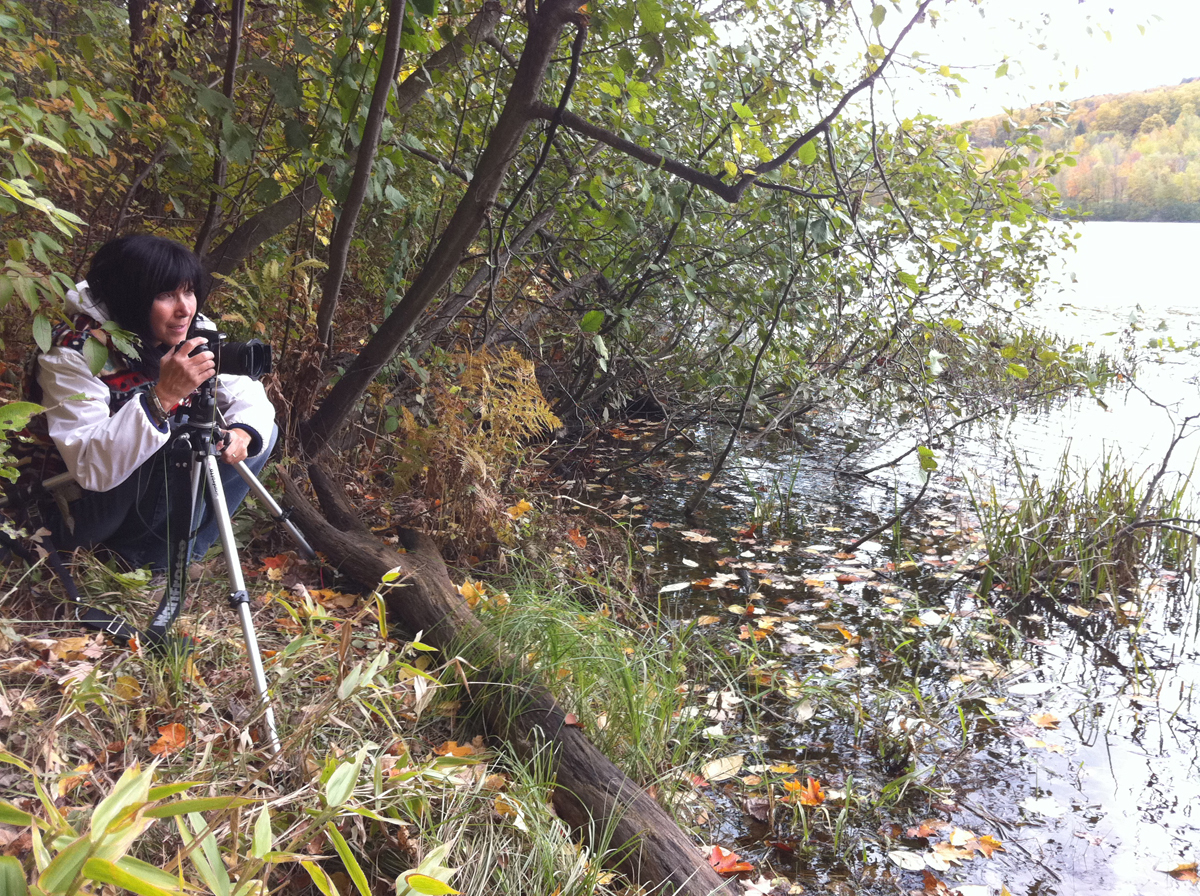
[37,282,275,492]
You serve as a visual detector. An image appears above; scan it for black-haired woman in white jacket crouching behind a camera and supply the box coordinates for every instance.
[22,234,276,570]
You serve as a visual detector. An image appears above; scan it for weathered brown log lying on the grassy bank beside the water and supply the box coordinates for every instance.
[278,463,727,896]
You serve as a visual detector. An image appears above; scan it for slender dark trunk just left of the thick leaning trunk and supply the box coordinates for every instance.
[317,0,404,345]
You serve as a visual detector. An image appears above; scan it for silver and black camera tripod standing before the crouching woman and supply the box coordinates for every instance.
[156,375,316,756]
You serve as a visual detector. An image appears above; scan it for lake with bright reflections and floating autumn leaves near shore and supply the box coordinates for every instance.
[608,223,1200,896]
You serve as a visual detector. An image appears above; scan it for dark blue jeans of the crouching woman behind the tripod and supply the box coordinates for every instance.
[47,427,280,572]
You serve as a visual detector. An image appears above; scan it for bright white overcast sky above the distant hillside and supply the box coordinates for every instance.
[884,0,1200,121]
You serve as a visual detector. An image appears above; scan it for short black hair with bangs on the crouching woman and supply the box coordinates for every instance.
[88,234,204,347]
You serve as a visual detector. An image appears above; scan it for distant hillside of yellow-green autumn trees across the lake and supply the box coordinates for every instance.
[968,78,1200,221]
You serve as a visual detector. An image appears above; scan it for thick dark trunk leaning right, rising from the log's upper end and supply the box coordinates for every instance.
[301,0,582,457]
